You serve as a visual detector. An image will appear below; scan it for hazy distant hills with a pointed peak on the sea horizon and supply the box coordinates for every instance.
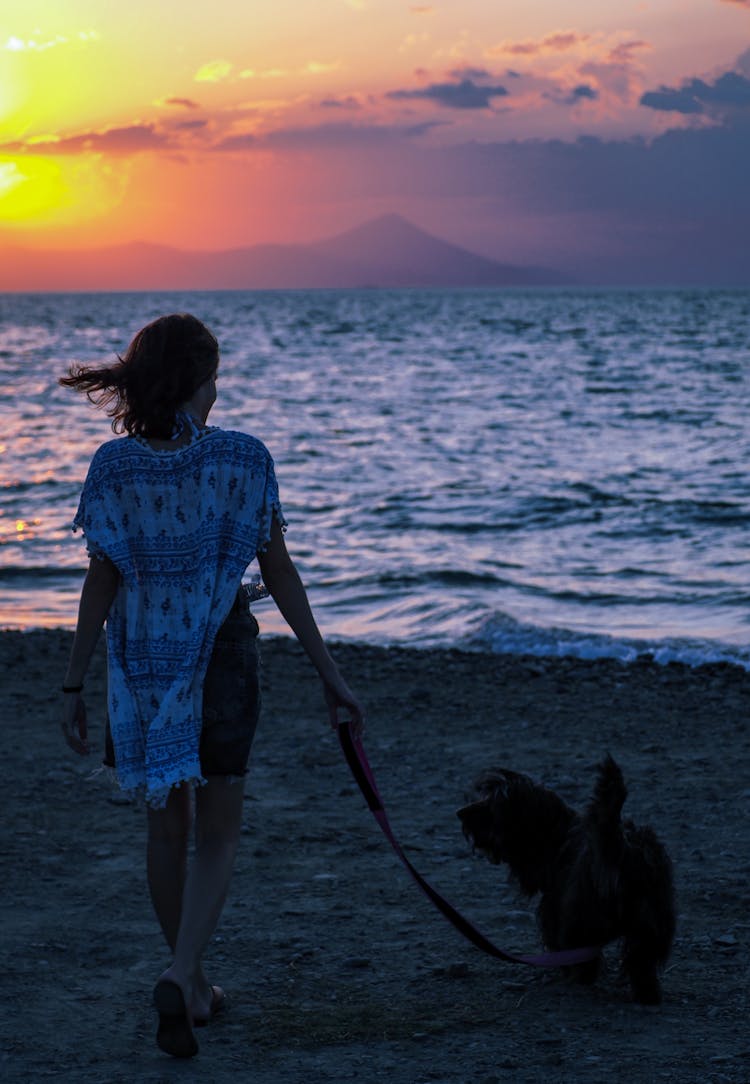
[0,215,569,291]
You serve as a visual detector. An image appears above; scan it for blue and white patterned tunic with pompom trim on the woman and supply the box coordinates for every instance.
[73,428,284,805]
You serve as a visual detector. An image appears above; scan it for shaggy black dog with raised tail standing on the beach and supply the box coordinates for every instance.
[458,757,675,1005]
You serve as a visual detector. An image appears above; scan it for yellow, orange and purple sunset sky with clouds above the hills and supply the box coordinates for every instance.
[0,0,750,281]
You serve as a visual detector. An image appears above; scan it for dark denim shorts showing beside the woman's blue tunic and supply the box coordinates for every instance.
[103,589,260,776]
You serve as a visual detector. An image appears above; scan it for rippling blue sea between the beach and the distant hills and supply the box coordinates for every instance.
[0,288,750,668]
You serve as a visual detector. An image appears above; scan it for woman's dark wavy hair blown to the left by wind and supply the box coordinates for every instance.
[60,312,219,439]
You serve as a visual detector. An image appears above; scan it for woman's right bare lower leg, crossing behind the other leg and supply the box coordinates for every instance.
[161,776,243,1017]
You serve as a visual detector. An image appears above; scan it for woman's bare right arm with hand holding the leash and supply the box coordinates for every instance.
[258,518,364,737]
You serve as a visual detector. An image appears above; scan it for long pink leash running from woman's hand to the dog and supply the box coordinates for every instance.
[338,723,599,967]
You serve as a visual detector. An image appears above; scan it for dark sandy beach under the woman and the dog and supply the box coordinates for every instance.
[0,631,750,1084]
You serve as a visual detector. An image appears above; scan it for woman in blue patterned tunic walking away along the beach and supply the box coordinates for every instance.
[61,314,363,1057]
